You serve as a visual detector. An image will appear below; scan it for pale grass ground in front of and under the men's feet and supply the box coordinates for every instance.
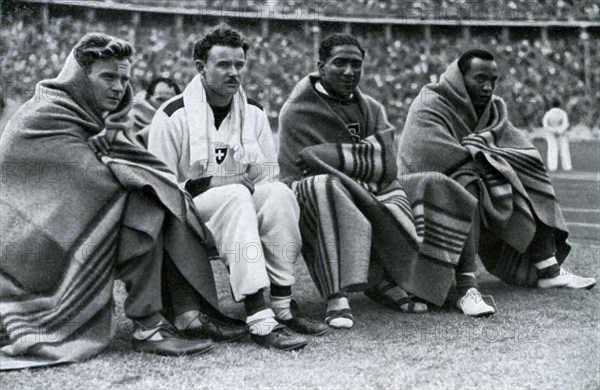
[0,243,600,389]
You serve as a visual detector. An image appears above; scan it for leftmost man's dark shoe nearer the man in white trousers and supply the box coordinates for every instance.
[181,312,248,342]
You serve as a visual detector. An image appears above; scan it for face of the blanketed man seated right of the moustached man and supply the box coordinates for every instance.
[318,45,363,99]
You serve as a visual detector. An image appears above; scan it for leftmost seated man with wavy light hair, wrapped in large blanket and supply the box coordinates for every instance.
[0,34,247,369]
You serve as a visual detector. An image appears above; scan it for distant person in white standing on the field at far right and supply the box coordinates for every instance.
[542,98,573,171]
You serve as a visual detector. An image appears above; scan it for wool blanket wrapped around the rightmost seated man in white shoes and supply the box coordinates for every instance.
[396,61,570,285]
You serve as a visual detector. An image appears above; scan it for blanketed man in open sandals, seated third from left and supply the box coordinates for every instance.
[279,34,490,328]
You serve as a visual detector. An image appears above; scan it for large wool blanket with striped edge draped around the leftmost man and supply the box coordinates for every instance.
[0,53,218,369]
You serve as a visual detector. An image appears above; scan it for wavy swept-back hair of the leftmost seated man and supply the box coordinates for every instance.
[73,33,133,72]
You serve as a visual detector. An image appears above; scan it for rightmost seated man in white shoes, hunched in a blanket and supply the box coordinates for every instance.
[396,50,596,307]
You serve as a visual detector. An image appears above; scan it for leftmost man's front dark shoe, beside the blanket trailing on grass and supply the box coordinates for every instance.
[131,321,213,356]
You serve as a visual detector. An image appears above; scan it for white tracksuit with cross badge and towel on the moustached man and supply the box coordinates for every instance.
[148,76,301,302]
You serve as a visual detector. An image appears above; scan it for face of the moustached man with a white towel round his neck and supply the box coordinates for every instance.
[196,45,246,97]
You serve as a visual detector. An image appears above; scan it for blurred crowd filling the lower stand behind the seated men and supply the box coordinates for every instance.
[0,12,600,129]
